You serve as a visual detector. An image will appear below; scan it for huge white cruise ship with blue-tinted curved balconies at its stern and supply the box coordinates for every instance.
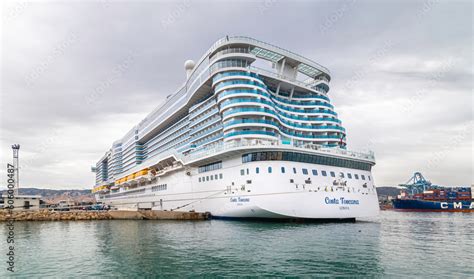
[92,36,379,220]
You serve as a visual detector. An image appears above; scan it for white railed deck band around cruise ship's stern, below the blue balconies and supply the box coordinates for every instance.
[184,139,375,162]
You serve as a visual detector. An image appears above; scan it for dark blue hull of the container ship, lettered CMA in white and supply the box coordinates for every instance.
[392,199,474,211]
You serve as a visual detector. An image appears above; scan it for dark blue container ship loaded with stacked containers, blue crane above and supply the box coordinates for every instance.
[392,172,474,212]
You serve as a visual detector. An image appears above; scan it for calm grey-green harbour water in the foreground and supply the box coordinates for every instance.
[0,211,474,278]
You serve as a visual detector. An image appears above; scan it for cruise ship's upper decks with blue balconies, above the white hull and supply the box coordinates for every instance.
[95,36,373,192]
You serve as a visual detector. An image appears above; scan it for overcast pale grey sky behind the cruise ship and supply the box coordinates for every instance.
[0,0,474,189]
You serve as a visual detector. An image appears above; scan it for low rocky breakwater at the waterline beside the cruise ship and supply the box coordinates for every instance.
[0,210,210,222]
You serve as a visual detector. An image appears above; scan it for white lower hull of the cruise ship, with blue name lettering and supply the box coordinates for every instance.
[98,153,379,219]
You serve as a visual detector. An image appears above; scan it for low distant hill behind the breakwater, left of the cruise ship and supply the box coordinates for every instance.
[2,188,95,203]
